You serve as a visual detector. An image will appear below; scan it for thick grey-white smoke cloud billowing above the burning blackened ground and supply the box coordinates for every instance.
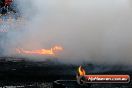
[1,0,132,64]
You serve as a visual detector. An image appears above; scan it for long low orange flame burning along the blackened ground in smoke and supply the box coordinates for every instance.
[16,46,63,55]
